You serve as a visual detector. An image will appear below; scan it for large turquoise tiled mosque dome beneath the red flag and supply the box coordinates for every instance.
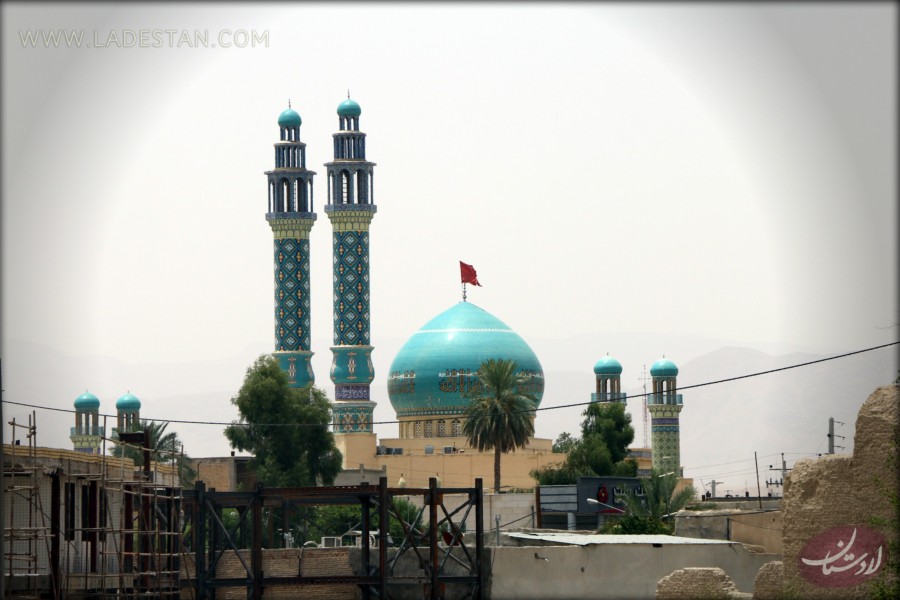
[388,302,544,417]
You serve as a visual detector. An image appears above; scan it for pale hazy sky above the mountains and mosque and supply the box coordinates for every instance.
[2,2,898,488]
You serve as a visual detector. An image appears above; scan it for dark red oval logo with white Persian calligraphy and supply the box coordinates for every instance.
[798,525,885,587]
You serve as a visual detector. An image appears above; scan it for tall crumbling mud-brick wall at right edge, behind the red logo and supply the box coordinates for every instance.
[782,384,900,600]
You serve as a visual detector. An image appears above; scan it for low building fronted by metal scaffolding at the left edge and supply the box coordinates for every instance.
[3,416,181,599]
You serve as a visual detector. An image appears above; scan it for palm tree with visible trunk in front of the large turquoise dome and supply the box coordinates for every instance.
[463,358,537,493]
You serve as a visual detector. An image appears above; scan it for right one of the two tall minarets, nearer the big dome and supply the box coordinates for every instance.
[325,93,377,440]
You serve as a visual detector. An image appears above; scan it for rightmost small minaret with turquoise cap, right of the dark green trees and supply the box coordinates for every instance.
[647,357,684,477]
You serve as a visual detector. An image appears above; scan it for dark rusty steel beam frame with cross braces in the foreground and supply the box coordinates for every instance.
[181,477,484,600]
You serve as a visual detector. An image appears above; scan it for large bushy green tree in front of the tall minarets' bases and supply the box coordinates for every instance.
[225,354,343,487]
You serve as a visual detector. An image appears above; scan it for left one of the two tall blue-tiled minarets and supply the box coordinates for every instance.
[266,102,316,388]
